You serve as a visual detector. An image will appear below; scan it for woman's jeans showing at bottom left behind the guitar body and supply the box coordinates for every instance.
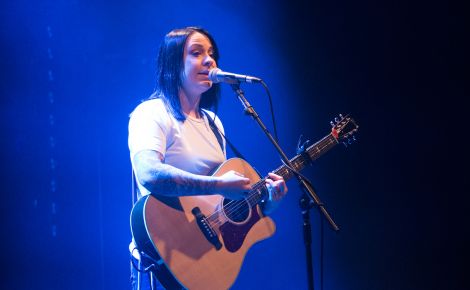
[131,255,165,290]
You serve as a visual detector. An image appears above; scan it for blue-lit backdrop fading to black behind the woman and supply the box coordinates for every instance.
[0,0,470,289]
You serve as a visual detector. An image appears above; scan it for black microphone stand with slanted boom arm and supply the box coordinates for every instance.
[230,81,339,290]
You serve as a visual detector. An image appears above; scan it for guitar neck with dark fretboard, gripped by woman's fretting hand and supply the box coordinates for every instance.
[248,133,338,206]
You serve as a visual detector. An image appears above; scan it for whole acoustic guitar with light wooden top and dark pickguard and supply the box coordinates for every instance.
[131,115,358,290]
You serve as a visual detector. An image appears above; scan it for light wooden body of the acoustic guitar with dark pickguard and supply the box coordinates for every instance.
[131,158,275,290]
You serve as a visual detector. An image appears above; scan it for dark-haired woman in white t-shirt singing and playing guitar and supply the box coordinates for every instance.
[129,27,287,289]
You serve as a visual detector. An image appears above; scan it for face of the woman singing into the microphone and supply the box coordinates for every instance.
[181,32,217,97]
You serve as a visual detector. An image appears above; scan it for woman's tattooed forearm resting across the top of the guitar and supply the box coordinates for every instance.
[134,150,217,196]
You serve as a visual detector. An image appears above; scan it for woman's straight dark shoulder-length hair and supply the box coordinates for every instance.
[150,27,220,121]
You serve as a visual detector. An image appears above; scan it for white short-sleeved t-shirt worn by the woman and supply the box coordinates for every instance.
[128,99,226,195]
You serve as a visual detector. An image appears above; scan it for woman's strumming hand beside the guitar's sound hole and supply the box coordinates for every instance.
[217,170,251,200]
